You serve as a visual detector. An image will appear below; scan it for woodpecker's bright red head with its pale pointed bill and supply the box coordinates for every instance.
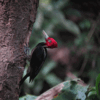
[43,31,58,48]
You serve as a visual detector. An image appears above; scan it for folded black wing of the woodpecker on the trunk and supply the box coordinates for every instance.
[30,46,47,80]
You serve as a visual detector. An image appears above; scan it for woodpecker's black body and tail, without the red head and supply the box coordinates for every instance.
[19,42,47,86]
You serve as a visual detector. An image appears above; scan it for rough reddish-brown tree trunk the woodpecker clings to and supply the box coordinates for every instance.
[0,0,39,100]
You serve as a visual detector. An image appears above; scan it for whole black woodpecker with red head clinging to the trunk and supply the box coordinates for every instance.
[19,31,57,86]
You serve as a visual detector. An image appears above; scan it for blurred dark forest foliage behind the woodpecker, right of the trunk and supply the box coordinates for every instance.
[20,0,100,96]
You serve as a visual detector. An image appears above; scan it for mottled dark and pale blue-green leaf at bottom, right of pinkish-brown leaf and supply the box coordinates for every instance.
[53,80,88,100]
